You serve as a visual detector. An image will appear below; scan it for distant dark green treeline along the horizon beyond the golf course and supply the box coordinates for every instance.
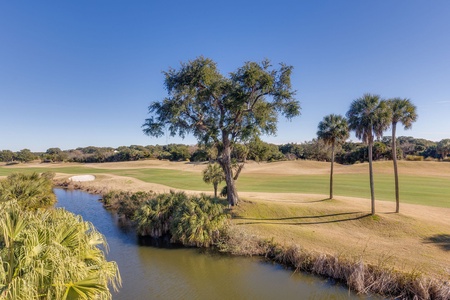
[0,137,450,164]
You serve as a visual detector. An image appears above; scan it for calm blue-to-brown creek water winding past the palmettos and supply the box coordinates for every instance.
[55,189,368,299]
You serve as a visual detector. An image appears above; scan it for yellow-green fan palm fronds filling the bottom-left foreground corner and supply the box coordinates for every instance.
[0,200,121,299]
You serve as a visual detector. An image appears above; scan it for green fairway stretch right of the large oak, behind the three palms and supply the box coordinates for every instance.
[238,174,450,207]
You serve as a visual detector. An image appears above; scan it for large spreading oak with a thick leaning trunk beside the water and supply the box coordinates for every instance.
[143,57,300,205]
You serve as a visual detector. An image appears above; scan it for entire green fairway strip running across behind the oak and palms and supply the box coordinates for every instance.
[0,165,450,207]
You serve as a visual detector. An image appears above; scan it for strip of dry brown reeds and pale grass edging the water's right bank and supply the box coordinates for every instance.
[220,226,450,300]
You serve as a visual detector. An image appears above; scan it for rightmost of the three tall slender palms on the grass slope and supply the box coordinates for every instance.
[387,98,417,213]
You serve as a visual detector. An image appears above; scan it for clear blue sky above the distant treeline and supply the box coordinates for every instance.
[0,0,450,151]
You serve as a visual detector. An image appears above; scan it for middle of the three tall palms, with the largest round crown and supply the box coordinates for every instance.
[347,94,390,215]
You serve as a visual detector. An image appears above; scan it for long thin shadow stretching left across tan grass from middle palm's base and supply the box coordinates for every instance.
[235,212,371,225]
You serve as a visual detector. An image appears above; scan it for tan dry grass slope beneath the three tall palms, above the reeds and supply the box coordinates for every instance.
[234,195,450,280]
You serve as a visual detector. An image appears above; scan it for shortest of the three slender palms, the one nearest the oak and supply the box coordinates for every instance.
[317,114,349,199]
